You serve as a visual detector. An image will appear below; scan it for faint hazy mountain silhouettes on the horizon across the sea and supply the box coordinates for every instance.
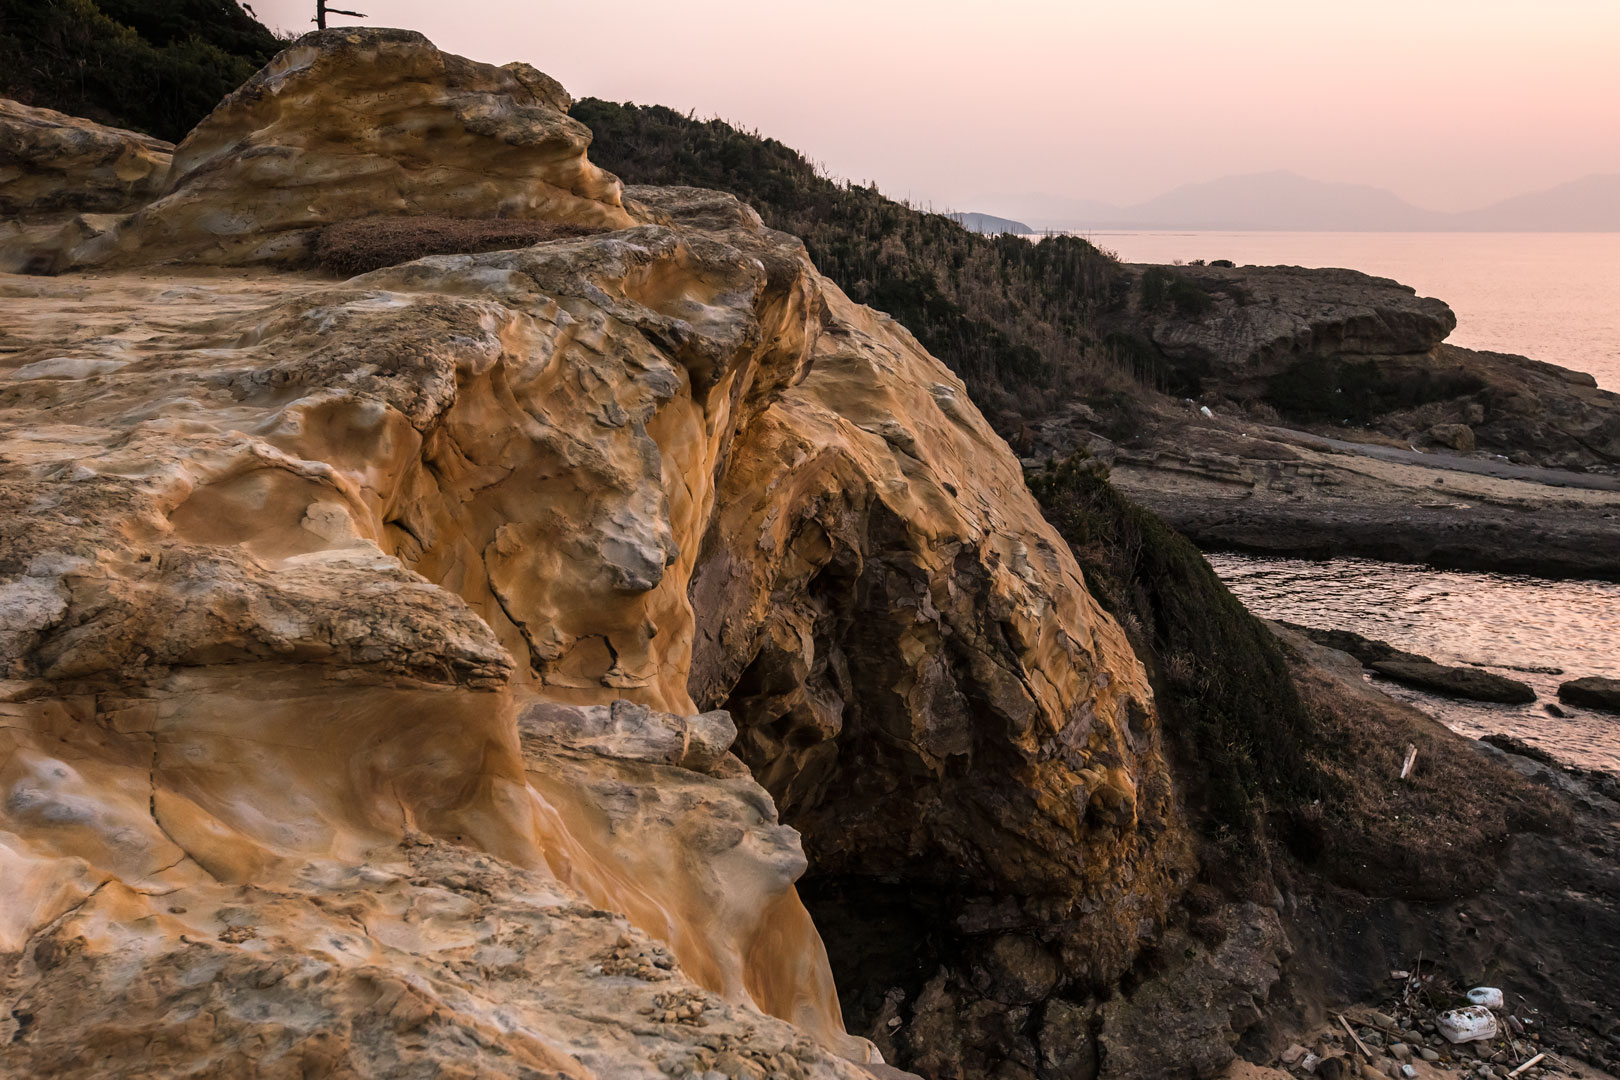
[1003,172,1620,232]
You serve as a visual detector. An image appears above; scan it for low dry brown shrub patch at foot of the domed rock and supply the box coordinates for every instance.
[314,217,603,277]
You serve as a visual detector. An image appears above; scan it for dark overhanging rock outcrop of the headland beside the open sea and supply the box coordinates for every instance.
[1105,266,1620,474]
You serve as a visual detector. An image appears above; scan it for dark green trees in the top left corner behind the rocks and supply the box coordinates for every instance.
[0,0,285,142]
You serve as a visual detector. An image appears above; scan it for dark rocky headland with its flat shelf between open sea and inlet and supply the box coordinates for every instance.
[1021,259,1620,580]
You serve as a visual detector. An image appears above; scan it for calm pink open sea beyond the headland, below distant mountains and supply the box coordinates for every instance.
[1087,232,1620,390]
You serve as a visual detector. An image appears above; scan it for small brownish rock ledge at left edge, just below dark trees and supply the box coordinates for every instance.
[0,97,175,217]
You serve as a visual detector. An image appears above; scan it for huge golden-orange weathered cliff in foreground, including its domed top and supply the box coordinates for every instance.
[0,31,1187,1080]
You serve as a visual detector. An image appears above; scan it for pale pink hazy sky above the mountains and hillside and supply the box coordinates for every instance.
[249,0,1620,212]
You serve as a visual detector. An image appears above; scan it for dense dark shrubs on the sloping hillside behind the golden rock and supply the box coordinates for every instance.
[573,97,1124,434]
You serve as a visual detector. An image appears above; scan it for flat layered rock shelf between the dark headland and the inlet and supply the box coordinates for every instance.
[1030,405,1620,580]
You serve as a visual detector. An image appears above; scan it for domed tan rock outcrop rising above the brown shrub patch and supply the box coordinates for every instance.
[0,29,633,270]
